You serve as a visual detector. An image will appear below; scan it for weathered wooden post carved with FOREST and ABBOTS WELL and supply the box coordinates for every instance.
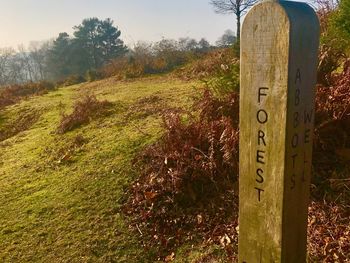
[239,1,319,263]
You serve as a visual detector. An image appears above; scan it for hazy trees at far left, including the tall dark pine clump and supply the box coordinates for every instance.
[0,18,128,85]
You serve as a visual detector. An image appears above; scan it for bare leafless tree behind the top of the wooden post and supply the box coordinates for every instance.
[210,0,258,41]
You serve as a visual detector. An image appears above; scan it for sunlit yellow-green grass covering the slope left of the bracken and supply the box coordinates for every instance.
[0,77,216,262]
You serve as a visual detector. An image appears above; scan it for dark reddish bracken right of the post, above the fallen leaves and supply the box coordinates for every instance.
[313,59,350,203]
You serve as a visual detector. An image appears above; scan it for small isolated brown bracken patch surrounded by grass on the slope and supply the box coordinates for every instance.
[57,95,113,134]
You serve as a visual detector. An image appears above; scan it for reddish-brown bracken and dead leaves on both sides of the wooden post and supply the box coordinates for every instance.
[124,56,350,262]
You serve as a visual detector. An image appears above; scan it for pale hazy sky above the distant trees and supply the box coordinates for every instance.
[0,0,236,47]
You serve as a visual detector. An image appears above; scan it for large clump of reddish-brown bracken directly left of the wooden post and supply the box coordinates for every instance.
[124,90,238,256]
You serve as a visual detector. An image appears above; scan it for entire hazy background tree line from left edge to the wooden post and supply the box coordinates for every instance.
[0,18,236,86]
